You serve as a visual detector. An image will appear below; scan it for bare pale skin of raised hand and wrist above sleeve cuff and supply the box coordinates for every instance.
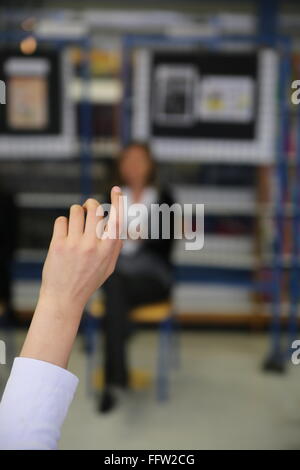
[20,187,122,368]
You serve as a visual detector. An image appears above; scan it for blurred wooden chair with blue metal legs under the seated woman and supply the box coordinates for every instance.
[83,299,179,401]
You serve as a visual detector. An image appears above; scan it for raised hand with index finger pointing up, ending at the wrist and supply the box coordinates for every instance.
[41,188,122,316]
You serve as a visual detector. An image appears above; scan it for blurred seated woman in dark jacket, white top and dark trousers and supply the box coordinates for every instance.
[99,142,173,412]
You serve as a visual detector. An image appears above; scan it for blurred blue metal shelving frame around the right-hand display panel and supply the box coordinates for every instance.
[122,23,292,370]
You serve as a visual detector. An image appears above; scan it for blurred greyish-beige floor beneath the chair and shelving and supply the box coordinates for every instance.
[1,331,300,450]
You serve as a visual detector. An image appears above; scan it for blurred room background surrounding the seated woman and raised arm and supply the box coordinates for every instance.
[0,0,300,449]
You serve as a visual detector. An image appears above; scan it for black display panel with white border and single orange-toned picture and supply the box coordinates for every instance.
[0,50,75,158]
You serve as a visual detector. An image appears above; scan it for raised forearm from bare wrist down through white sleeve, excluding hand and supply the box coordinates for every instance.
[0,291,82,449]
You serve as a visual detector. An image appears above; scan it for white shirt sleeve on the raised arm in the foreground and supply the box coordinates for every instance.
[0,357,78,450]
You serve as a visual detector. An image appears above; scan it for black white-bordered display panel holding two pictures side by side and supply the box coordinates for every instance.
[132,49,278,164]
